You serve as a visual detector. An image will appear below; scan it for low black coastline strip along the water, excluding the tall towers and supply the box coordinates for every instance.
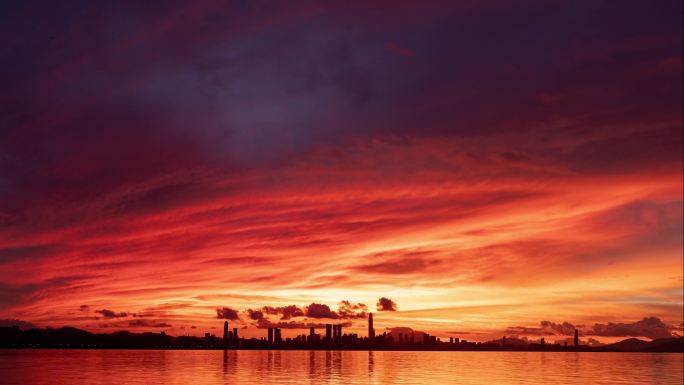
[0,327,684,353]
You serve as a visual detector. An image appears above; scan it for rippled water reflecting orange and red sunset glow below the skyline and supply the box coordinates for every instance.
[0,350,684,385]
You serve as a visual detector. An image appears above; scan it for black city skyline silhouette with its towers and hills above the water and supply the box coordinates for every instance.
[0,313,684,353]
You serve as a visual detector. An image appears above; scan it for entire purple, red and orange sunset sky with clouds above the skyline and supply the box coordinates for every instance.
[0,0,684,341]
